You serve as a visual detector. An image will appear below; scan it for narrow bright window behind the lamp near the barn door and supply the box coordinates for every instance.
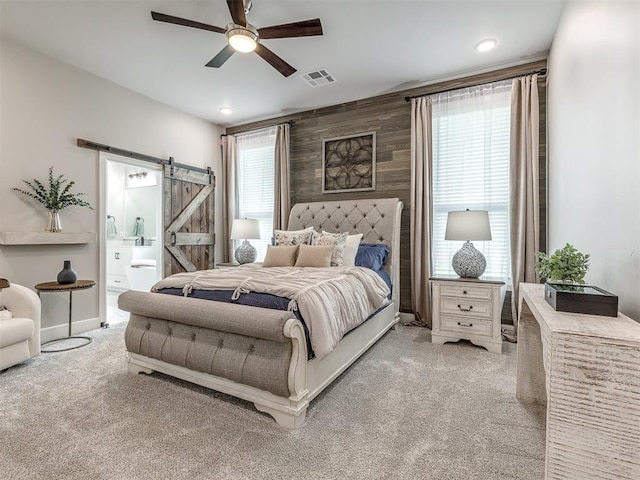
[233,128,276,262]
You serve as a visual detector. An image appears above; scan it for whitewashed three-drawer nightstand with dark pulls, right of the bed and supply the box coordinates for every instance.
[429,277,504,353]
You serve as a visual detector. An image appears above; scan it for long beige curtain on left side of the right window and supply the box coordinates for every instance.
[410,97,433,328]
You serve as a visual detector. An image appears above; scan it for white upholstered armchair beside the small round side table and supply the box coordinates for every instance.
[0,279,40,370]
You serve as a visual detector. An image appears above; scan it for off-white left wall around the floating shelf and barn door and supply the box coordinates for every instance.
[0,38,222,334]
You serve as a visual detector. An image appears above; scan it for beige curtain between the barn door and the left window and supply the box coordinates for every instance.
[220,135,237,263]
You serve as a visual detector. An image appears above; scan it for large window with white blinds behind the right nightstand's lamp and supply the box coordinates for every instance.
[432,80,511,280]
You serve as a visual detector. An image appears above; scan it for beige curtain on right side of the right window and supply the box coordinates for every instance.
[510,74,540,335]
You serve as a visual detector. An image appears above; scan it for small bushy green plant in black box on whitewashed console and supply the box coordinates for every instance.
[536,243,590,285]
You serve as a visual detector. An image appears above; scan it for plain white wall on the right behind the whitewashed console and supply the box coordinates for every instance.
[548,0,640,321]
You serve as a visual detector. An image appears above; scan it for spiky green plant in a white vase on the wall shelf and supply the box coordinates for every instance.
[13,167,93,232]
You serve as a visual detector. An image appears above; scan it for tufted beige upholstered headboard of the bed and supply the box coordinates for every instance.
[288,198,403,314]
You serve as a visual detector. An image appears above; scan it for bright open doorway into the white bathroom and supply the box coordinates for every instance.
[101,153,163,324]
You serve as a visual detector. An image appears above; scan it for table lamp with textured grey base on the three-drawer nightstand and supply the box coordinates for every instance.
[444,209,491,278]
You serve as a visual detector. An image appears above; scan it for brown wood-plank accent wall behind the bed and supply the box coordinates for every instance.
[226,60,547,312]
